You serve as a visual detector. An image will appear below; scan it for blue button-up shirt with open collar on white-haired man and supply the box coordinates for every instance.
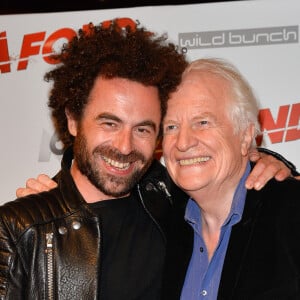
[180,164,250,300]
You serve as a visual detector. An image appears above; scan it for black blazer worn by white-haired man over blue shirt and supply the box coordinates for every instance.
[163,179,300,300]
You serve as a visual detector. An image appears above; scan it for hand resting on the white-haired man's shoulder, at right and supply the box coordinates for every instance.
[245,155,291,190]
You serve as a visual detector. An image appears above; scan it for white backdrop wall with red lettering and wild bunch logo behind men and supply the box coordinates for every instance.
[0,0,300,204]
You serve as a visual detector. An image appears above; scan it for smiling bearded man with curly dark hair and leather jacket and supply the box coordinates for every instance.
[0,22,298,300]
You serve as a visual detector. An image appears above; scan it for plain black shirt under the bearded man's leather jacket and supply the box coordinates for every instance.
[90,196,165,300]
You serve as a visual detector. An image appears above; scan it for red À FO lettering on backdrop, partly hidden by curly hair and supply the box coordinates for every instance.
[0,18,137,73]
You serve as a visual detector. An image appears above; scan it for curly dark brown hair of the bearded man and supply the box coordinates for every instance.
[44,19,187,148]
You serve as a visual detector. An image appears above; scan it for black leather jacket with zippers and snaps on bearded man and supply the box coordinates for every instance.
[0,148,179,300]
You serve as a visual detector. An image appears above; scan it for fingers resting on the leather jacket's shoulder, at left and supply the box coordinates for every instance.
[16,174,57,198]
